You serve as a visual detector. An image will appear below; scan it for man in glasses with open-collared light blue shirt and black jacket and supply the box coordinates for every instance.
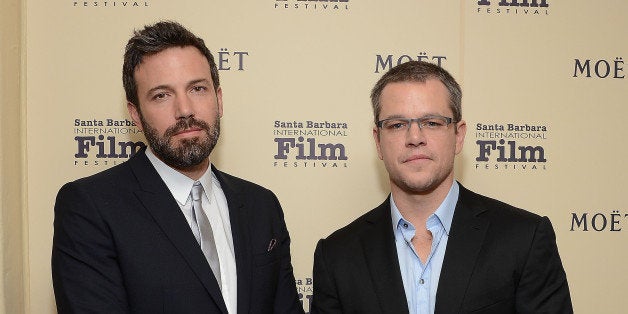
[312,61,573,314]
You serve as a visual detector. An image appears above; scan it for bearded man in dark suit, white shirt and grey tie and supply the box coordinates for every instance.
[52,22,303,314]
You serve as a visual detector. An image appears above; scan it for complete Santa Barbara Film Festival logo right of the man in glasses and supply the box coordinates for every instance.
[472,122,549,172]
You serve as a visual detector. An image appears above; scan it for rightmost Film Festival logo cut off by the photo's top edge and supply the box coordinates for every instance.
[475,0,550,16]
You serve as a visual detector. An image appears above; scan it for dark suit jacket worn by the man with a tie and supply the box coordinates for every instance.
[52,151,303,314]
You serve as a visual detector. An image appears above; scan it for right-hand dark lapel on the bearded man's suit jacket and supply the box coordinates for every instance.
[212,165,253,313]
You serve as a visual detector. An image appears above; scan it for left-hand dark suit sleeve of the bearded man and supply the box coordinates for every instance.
[52,183,129,314]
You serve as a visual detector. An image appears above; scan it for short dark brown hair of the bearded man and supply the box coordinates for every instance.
[122,21,220,109]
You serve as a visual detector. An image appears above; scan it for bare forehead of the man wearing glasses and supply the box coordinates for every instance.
[380,79,452,118]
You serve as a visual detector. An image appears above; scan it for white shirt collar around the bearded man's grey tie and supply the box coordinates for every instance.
[146,149,213,206]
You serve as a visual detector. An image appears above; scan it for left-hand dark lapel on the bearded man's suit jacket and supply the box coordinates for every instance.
[128,151,227,314]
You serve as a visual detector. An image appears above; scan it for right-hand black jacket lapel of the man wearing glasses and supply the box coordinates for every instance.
[435,185,489,313]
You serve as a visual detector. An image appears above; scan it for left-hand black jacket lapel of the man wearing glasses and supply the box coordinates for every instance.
[361,199,408,314]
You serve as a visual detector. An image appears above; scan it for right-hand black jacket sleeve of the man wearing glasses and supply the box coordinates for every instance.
[516,217,573,313]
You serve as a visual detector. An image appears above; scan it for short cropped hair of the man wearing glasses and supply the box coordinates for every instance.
[371,61,462,124]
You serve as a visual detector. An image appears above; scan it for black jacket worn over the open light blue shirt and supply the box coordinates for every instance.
[312,186,573,314]
